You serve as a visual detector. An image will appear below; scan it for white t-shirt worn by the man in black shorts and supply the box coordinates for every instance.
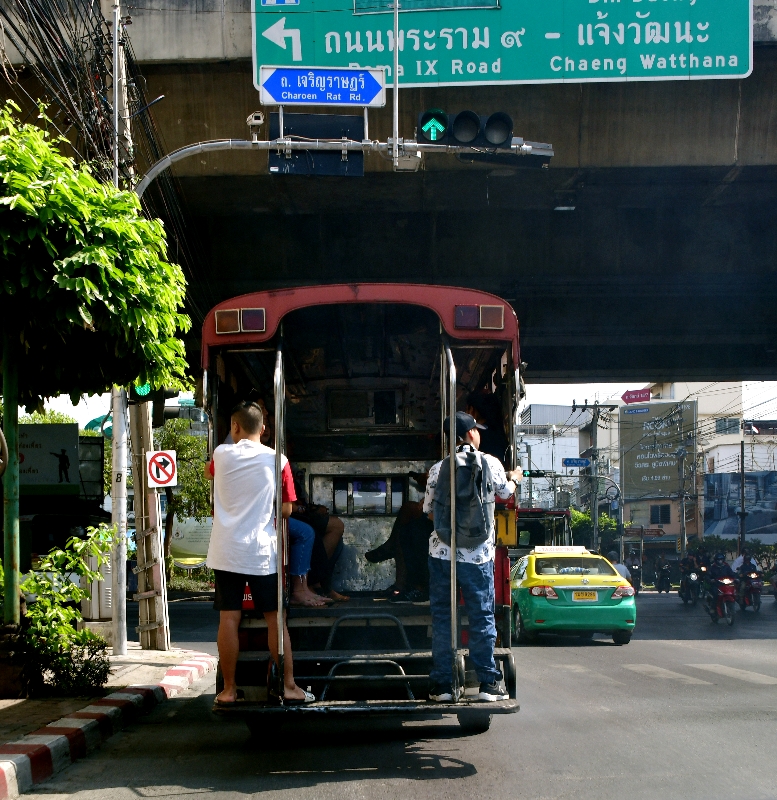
[207,439,287,575]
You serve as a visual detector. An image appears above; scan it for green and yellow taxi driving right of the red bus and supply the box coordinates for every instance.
[510,546,637,644]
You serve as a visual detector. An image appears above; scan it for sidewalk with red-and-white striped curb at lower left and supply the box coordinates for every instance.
[0,642,218,800]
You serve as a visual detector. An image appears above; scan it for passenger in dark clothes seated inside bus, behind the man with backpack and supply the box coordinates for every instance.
[365,391,508,603]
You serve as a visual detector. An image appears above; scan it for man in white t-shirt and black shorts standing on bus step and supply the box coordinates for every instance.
[205,402,315,705]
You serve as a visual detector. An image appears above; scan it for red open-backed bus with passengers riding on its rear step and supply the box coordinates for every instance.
[202,283,521,732]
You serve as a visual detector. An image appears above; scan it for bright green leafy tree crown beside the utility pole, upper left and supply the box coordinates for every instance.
[0,101,190,409]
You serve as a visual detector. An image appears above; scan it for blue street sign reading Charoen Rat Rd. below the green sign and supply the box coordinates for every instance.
[259,66,386,108]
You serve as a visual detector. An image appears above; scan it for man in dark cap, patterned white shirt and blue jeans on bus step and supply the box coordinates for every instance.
[424,411,522,703]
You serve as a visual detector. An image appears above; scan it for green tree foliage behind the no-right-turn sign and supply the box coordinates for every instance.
[154,419,210,522]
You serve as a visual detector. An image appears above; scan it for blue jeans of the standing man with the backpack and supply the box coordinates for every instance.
[429,556,502,686]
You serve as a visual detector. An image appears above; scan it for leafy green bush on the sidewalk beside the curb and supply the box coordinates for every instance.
[21,525,115,694]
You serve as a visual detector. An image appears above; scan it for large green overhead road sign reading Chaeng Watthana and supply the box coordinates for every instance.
[251,0,753,88]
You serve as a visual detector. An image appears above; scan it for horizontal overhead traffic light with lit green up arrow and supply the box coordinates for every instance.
[417,108,513,149]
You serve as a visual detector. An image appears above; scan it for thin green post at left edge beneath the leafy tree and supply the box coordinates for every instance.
[3,330,20,625]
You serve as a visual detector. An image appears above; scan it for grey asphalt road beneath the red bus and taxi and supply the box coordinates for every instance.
[36,593,777,800]
